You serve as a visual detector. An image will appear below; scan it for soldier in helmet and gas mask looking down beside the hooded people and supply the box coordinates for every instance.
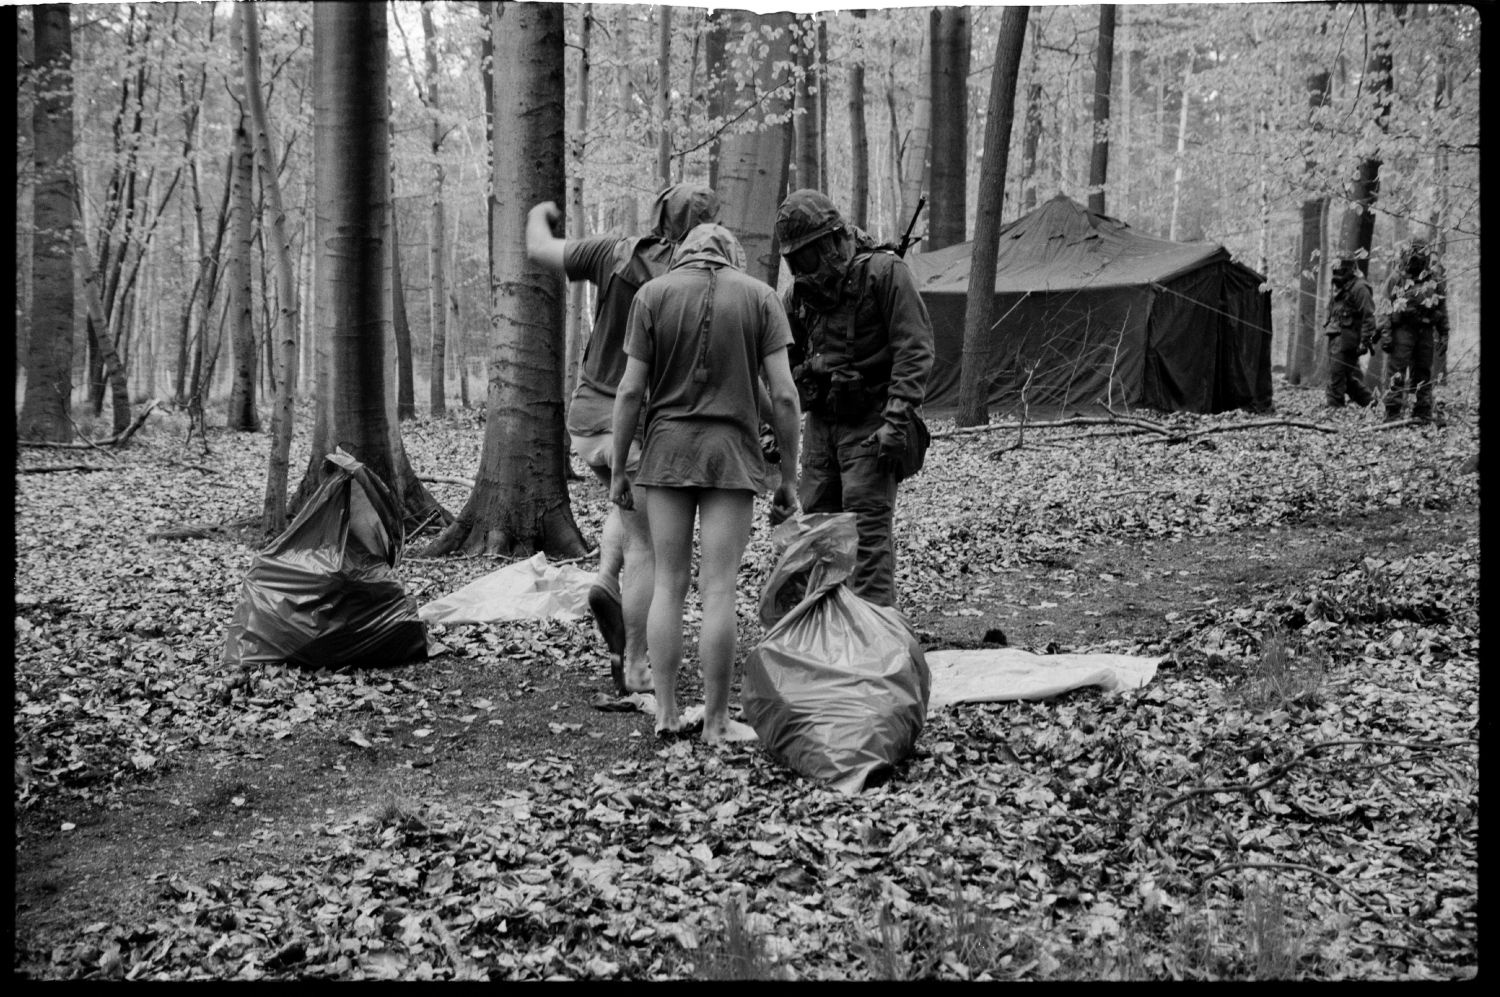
[776,190,933,607]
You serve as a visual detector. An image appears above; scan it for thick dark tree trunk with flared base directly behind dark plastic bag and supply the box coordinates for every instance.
[290,1,450,528]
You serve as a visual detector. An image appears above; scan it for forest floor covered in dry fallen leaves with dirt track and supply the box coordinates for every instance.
[14,385,1481,979]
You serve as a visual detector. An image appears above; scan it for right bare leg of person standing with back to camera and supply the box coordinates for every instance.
[698,489,756,744]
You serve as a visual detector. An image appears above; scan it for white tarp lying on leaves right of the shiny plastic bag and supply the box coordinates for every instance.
[924,648,1161,712]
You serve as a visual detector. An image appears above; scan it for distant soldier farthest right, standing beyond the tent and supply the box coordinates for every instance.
[1380,235,1448,423]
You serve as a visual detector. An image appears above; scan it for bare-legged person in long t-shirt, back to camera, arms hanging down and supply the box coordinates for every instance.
[609,225,801,744]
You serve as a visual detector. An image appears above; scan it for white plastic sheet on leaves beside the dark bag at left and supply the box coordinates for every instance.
[417,553,594,624]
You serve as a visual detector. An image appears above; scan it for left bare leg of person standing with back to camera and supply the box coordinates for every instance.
[642,487,698,733]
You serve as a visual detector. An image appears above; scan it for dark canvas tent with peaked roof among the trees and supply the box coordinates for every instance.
[908,193,1271,412]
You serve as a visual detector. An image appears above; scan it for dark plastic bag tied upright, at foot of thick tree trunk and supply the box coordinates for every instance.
[224,450,428,669]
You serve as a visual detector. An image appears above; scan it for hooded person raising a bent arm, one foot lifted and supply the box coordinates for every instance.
[527,183,719,696]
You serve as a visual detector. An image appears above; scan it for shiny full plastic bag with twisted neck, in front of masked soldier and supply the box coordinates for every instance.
[740,513,932,795]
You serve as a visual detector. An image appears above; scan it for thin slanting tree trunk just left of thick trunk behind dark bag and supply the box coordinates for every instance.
[234,3,302,540]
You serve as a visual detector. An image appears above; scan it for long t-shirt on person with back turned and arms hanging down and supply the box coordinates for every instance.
[626,264,792,492]
